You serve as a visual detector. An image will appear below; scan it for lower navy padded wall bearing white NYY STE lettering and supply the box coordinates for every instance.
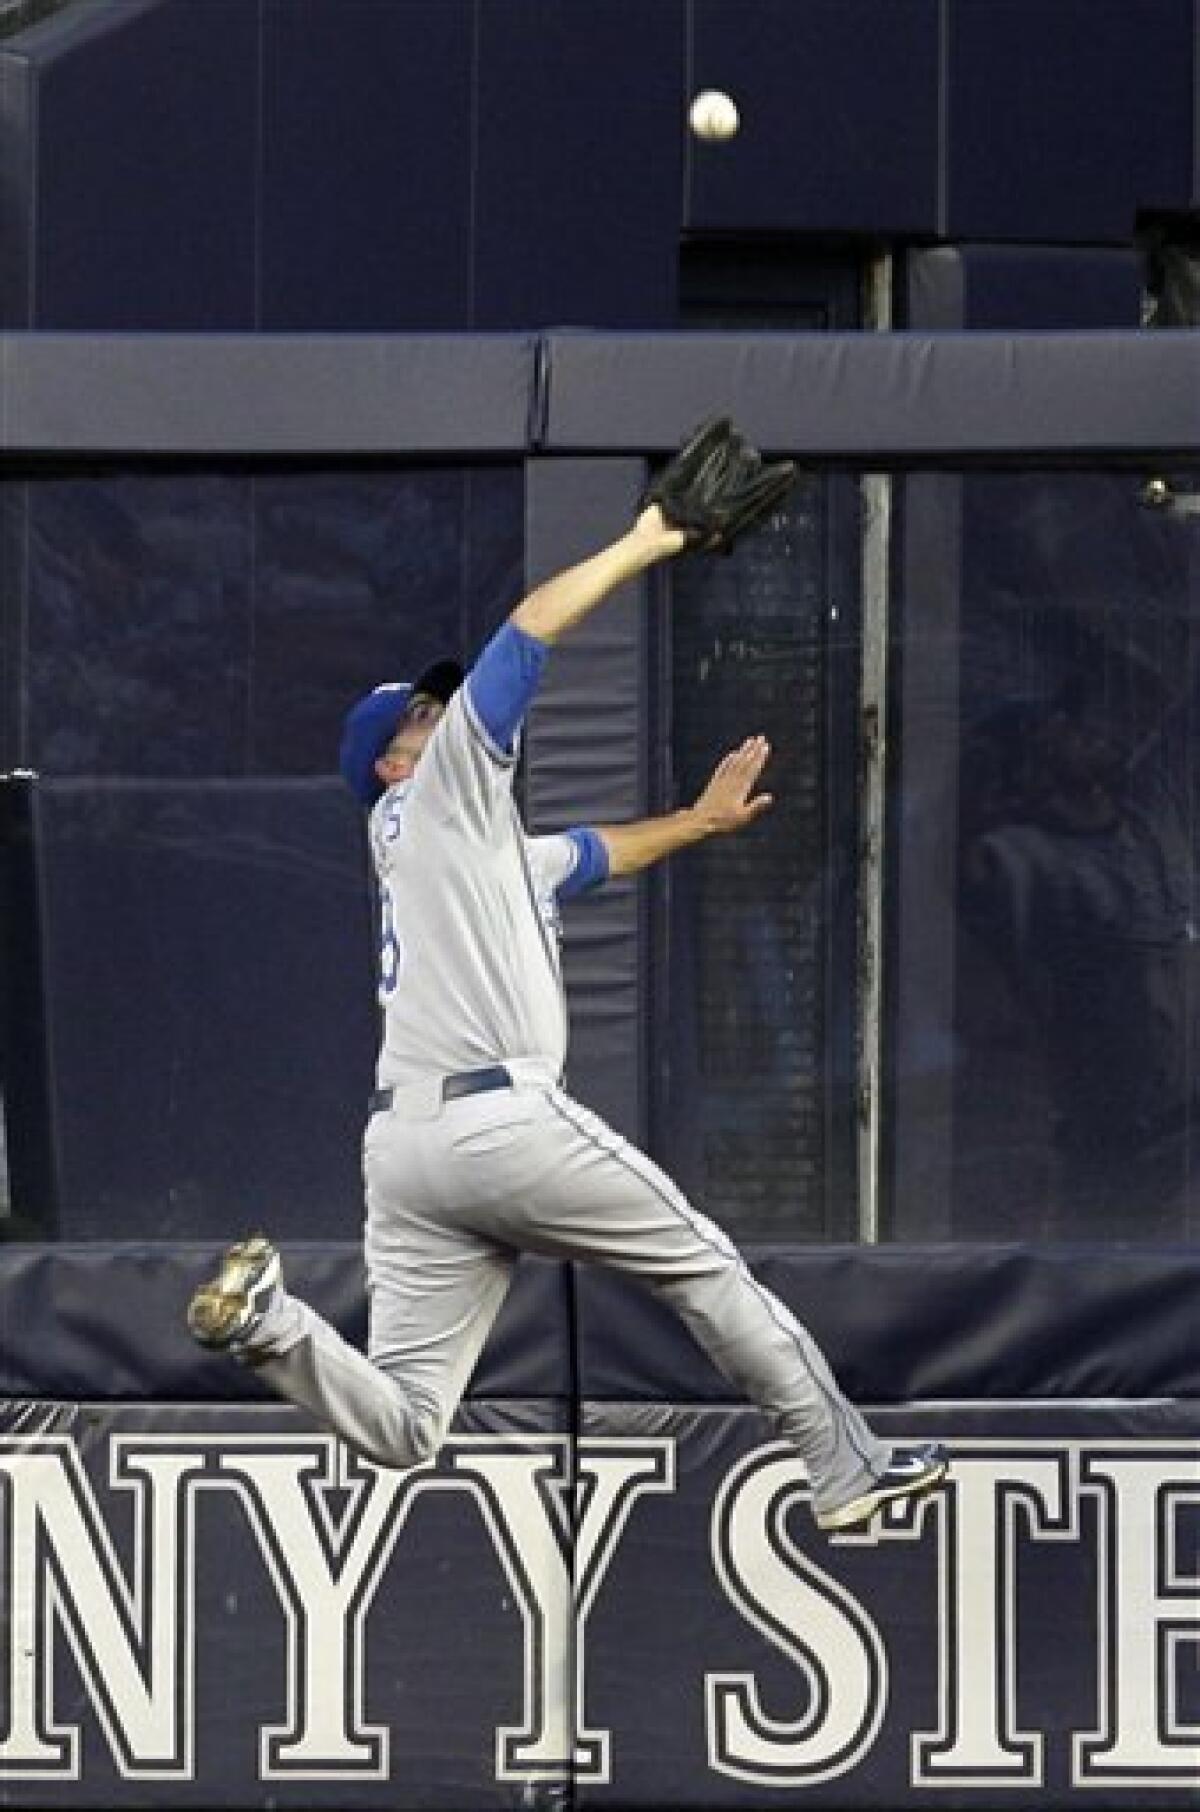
[0,1243,1200,1812]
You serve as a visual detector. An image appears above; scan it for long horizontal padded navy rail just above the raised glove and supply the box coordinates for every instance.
[0,328,1200,460]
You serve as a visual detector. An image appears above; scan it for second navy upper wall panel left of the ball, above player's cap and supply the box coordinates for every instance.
[261,0,475,332]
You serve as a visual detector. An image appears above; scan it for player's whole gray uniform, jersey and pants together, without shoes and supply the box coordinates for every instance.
[242,631,888,1509]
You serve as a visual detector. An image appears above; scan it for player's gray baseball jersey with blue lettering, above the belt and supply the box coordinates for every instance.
[370,685,576,1087]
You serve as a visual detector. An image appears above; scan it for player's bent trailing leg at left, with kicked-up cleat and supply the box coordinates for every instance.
[189,1192,513,1468]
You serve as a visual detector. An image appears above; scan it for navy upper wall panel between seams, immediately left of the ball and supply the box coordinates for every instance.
[469,0,685,328]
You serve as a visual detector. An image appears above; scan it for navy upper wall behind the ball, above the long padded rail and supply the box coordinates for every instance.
[0,0,1198,330]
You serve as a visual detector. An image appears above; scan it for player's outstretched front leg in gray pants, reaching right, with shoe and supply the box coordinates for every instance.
[460,1091,946,1528]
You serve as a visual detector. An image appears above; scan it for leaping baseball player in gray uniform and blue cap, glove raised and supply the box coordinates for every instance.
[189,420,948,1529]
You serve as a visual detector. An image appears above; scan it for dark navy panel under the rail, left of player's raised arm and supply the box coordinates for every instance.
[0,464,524,779]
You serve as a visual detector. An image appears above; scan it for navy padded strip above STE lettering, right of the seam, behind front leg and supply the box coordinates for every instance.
[576,1245,1200,1402]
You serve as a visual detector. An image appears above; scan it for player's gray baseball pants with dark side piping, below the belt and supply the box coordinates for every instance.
[254,1065,890,1511]
